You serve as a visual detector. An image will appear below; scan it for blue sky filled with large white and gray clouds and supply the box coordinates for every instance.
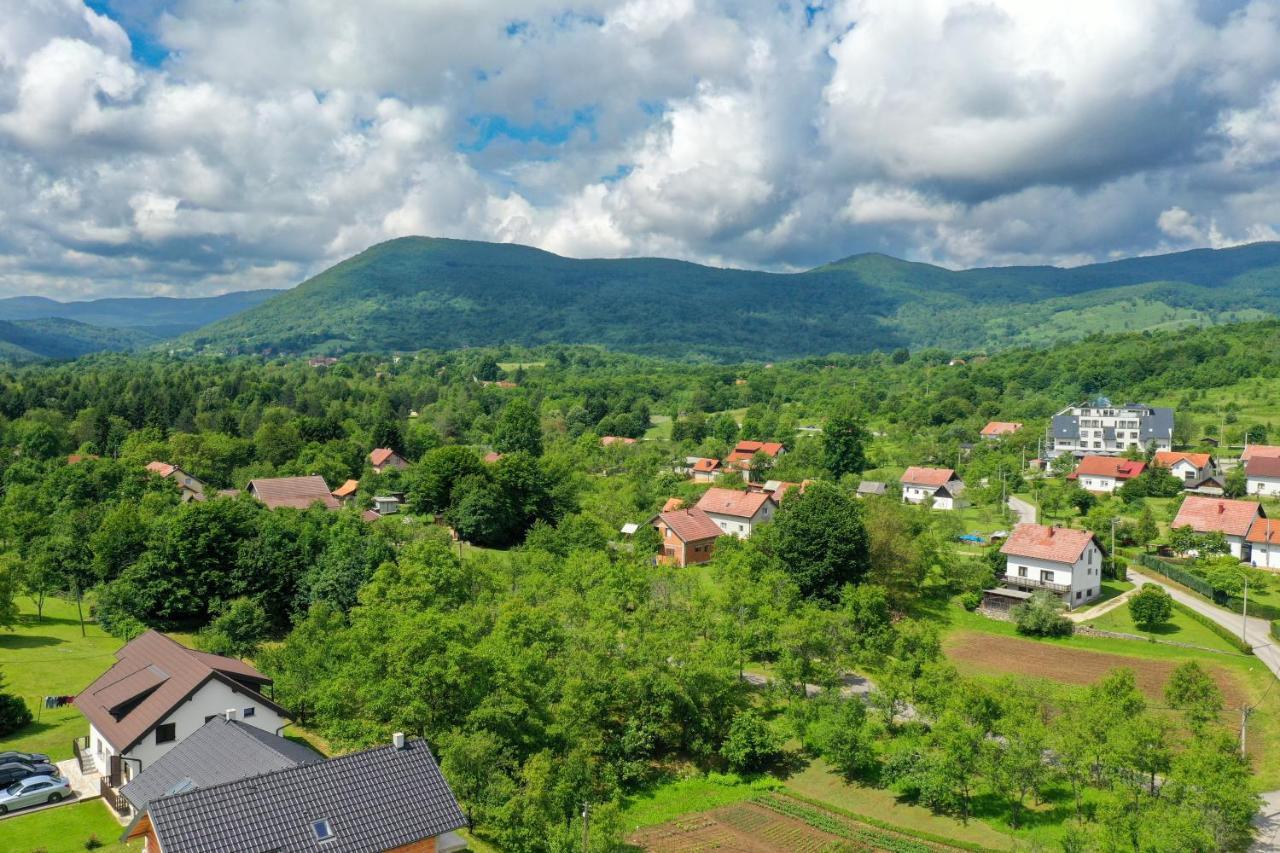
[0,0,1280,300]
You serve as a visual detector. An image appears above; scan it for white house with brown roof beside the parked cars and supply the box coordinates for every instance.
[76,631,288,811]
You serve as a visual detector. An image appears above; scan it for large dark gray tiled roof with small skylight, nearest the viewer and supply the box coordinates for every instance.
[147,739,467,853]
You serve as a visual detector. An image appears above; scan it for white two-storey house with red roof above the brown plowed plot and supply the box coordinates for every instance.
[1000,524,1106,607]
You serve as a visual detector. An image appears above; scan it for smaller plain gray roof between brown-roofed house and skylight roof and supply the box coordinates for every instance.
[120,716,324,811]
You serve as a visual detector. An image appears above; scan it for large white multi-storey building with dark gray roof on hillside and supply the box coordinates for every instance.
[1044,397,1174,459]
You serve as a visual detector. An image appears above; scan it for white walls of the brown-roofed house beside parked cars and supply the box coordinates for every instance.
[88,679,289,781]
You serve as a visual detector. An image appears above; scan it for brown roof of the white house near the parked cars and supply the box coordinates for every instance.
[76,631,285,752]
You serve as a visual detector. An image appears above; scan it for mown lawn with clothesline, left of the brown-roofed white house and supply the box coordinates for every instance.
[0,597,120,758]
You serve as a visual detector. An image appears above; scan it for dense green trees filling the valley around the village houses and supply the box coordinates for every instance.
[0,321,1280,850]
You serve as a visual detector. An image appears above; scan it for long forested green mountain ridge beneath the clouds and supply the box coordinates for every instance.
[183,237,1280,360]
